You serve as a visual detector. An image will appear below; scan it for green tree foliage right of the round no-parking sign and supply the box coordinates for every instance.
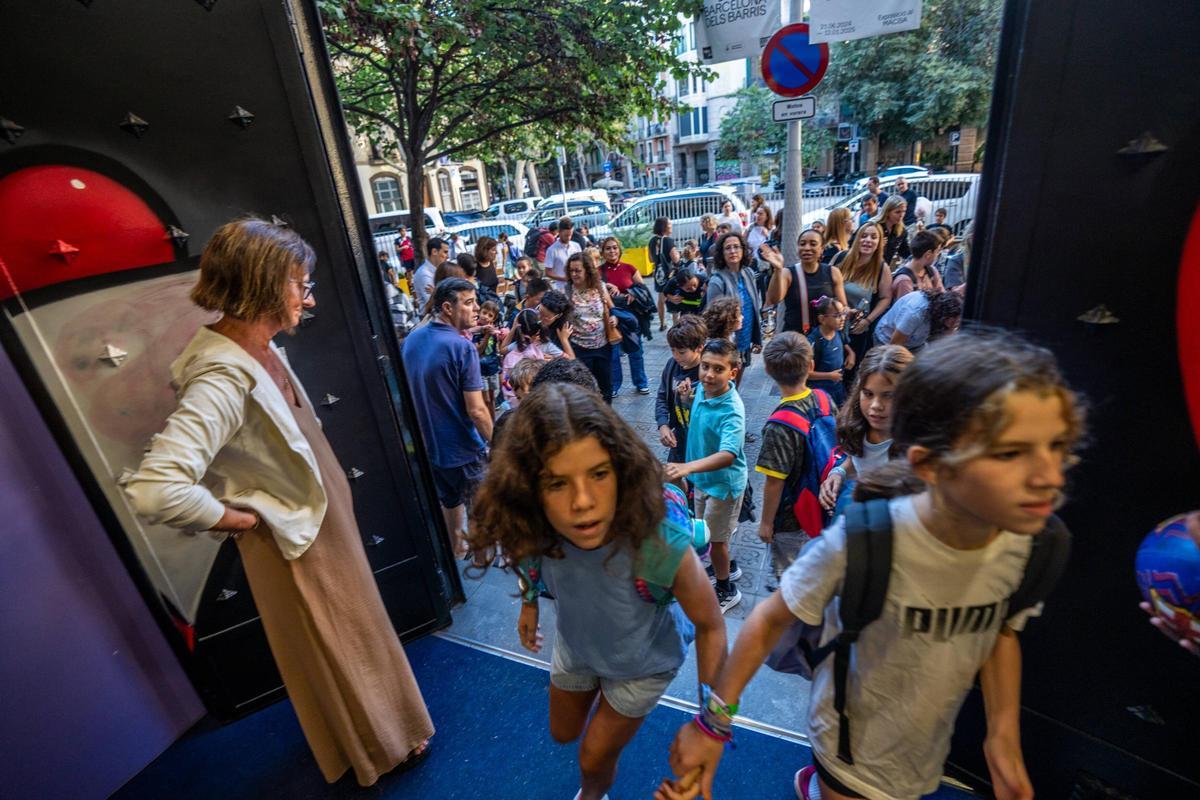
[826,0,1003,142]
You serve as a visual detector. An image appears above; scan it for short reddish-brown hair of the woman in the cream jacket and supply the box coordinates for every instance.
[191,217,317,324]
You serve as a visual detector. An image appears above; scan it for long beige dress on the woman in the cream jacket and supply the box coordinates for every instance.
[238,395,433,786]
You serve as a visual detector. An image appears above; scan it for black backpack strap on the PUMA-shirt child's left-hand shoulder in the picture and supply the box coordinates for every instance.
[833,499,892,764]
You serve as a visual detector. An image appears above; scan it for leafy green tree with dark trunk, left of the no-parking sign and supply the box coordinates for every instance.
[320,0,702,255]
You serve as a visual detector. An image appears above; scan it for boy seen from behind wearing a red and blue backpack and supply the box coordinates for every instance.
[755,331,838,583]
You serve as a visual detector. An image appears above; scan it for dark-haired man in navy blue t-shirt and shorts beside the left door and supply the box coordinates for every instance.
[402,278,492,558]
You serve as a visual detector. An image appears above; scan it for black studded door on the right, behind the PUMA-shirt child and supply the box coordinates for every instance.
[953,0,1200,799]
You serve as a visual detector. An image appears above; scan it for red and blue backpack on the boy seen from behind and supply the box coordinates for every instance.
[767,389,845,536]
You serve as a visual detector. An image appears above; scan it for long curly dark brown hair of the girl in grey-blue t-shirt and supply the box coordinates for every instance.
[468,384,666,570]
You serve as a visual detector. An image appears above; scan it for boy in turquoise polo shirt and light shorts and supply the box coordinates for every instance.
[666,339,746,614]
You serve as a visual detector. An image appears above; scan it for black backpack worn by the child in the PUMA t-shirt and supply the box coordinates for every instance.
[766,500,1070,764]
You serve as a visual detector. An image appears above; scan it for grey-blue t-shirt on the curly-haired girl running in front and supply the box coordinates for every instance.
[541,540,695,680]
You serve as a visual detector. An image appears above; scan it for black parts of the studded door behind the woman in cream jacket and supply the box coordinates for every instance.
[0,0,457,717]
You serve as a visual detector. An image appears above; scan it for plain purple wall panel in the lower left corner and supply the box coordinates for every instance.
[0,350,204,800]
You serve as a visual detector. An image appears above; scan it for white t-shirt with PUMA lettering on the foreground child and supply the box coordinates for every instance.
[780,497,1040,800]
